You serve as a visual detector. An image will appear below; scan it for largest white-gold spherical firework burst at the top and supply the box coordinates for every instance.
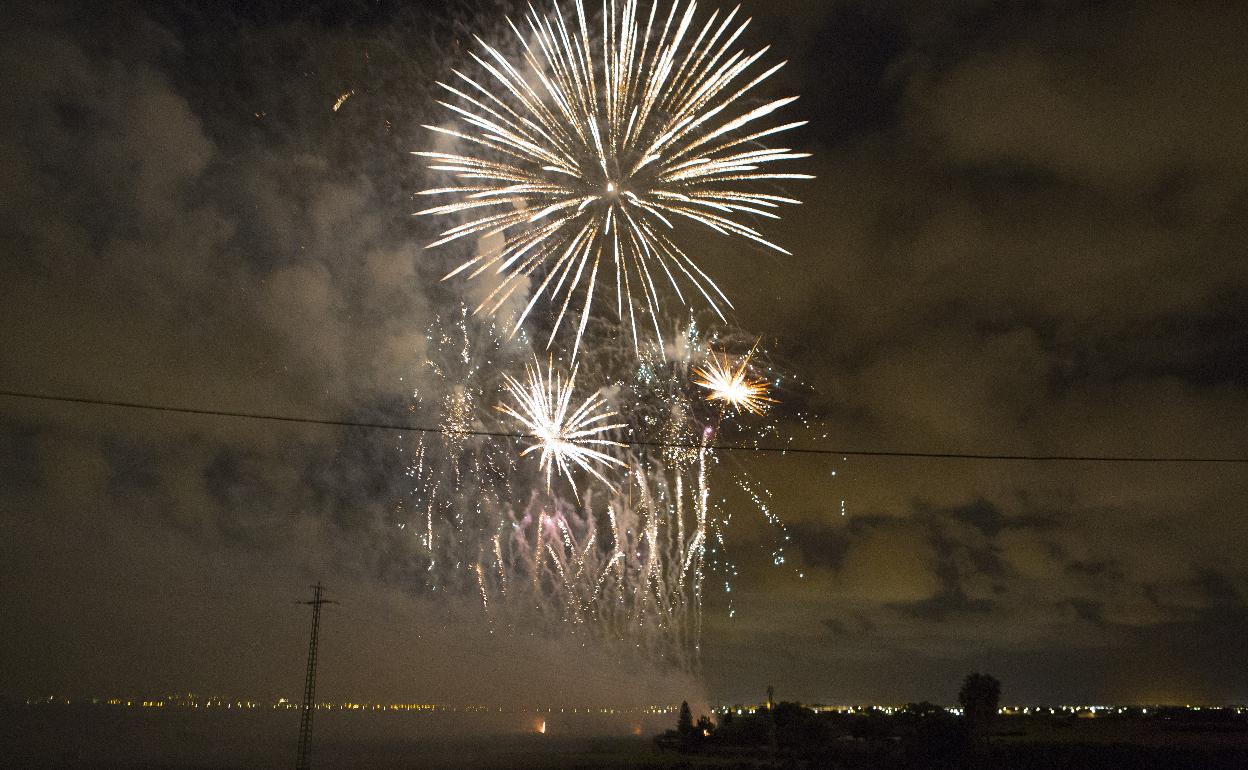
[416,0,810,359]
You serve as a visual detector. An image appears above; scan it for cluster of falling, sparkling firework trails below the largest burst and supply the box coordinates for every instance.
[404,311,798,670]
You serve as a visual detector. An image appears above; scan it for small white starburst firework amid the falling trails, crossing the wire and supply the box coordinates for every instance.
[497,362,625,490]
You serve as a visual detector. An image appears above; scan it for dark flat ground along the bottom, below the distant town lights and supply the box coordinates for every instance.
[0,705,1248,770]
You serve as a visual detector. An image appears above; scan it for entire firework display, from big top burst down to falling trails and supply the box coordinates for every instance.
[397,0,809,669]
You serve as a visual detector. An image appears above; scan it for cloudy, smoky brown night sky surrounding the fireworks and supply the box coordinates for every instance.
[0,0,1248,704]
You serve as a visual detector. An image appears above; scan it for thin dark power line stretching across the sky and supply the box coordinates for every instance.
[0,391,1248,464]
